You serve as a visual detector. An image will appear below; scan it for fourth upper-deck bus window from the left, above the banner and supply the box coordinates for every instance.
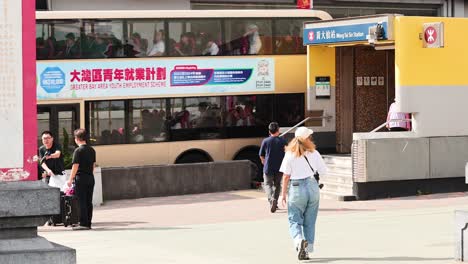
[168,19,222,56]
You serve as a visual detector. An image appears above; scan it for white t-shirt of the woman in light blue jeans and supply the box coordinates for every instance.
[280,151,327,180]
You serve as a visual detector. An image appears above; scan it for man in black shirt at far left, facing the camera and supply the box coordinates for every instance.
[39,131,65,184]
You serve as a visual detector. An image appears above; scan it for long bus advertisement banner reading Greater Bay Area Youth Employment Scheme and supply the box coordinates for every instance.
[37,58,275,99]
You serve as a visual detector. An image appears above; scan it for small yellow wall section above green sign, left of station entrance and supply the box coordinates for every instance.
[308,46,336,86]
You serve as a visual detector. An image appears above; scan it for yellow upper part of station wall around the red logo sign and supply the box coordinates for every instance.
[395,17,468,86]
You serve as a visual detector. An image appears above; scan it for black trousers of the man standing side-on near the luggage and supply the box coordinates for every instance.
[75,175,94,227]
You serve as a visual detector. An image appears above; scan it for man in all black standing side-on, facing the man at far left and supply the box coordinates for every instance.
[68,128,96,230]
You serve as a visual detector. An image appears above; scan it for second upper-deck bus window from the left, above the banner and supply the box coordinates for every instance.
[81,20,124,59]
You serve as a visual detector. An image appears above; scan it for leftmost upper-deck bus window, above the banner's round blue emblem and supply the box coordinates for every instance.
[36,20,81,60]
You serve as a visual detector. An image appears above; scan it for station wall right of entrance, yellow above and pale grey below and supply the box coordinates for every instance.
[395,17,468,137]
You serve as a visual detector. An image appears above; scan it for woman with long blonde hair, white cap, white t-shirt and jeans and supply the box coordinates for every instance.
[280,127,327,260]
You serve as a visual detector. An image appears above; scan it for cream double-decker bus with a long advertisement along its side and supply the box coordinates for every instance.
[36,10,331,179]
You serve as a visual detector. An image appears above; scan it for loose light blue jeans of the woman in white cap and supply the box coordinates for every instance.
[288,177,320,251]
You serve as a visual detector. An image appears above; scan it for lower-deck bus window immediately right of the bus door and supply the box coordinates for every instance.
[89,101,126,145]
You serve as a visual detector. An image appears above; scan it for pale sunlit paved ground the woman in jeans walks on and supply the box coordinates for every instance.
[39,190,468,264]
